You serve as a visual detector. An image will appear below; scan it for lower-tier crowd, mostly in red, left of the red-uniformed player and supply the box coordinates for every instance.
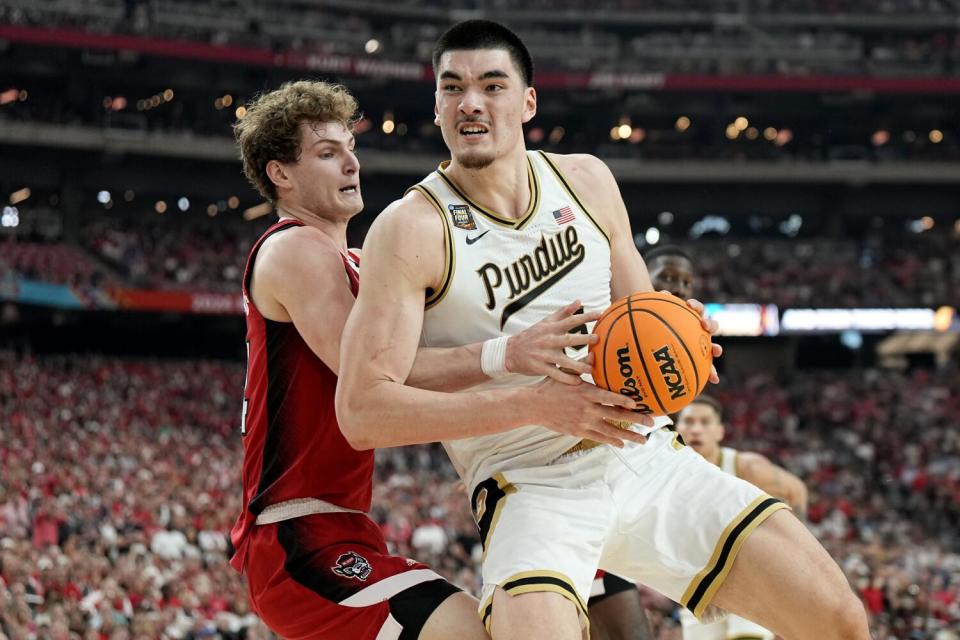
[0,352,264,640]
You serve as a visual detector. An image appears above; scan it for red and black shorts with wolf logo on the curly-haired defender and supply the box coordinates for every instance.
[246,513,459,640]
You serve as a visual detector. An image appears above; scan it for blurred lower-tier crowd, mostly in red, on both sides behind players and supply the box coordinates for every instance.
[0,351,960,640]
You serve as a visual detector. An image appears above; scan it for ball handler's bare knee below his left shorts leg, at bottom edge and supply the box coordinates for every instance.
[489,587,589,640]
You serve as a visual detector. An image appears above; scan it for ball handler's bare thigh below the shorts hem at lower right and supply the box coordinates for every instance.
[713,512,869,639]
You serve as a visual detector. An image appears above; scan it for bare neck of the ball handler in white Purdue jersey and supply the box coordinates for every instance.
[445,147,533,218]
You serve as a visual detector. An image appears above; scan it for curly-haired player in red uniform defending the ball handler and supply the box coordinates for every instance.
[231,82,629,640]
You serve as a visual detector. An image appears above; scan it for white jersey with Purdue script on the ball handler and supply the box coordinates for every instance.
[413,151,660,489]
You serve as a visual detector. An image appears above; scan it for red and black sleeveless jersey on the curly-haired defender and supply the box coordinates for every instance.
[230,220,373,571]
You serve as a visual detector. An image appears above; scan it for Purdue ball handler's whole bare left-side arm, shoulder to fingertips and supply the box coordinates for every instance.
[337,193,642,449]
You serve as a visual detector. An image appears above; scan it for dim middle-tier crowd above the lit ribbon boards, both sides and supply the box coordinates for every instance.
[0,219,960,307]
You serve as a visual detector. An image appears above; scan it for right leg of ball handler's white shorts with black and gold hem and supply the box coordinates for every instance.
[601,430,787,621]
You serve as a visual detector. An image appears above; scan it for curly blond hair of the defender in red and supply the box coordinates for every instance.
[233,80,358,202]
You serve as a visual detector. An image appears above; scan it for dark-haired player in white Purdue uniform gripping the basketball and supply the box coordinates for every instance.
[337,20,869,640]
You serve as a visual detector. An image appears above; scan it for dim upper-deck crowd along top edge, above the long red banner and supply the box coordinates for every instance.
[0,0,957,65]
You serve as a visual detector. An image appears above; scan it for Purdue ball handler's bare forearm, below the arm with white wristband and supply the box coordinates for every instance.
[337,380,531,450]
